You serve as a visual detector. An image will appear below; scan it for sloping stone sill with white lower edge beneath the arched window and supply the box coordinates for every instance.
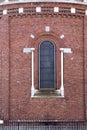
[31,90,64,98]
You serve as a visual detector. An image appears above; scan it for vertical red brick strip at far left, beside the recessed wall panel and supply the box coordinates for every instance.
[0,16,10,119]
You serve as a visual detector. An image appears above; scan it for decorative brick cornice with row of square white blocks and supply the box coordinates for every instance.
[0,5,87,18]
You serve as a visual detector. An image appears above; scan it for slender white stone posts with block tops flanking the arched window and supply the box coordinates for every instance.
[23,48,72,98]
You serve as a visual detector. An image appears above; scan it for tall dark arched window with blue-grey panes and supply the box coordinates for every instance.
[39,40,56,90]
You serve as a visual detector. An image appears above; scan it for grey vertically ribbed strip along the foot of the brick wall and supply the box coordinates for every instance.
[0,120,87,130]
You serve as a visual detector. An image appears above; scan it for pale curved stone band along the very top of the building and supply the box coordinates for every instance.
[0,0,87,6]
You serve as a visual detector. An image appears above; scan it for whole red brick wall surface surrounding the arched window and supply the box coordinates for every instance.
[0,3,87,120]
